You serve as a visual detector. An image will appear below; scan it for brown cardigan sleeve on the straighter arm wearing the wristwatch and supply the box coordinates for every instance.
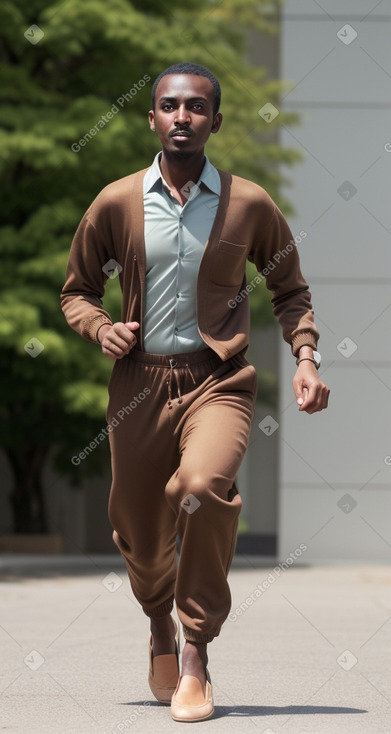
[249,201,319,356]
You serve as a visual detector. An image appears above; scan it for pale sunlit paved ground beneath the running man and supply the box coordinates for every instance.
[0,556,391,734]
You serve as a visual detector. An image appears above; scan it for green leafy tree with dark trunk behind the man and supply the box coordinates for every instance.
[0,0,298,532]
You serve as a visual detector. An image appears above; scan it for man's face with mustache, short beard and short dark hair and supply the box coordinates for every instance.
[149,74,222,154]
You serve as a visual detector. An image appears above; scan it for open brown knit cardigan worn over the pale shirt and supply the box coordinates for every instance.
[61,169,319,360]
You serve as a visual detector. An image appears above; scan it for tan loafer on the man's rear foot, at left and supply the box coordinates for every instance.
[148,620,179,704]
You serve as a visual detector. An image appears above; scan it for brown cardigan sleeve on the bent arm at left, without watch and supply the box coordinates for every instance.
[60,195,114,343]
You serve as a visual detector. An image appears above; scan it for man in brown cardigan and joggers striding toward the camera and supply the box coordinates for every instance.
[61,63,329,721]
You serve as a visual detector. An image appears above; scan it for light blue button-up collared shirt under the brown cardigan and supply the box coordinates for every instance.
[143,153,221,354]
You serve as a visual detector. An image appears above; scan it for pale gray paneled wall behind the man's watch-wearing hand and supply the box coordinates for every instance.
[279,0,391,560]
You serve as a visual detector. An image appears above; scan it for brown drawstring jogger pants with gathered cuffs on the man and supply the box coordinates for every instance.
[107,348,257,642]
